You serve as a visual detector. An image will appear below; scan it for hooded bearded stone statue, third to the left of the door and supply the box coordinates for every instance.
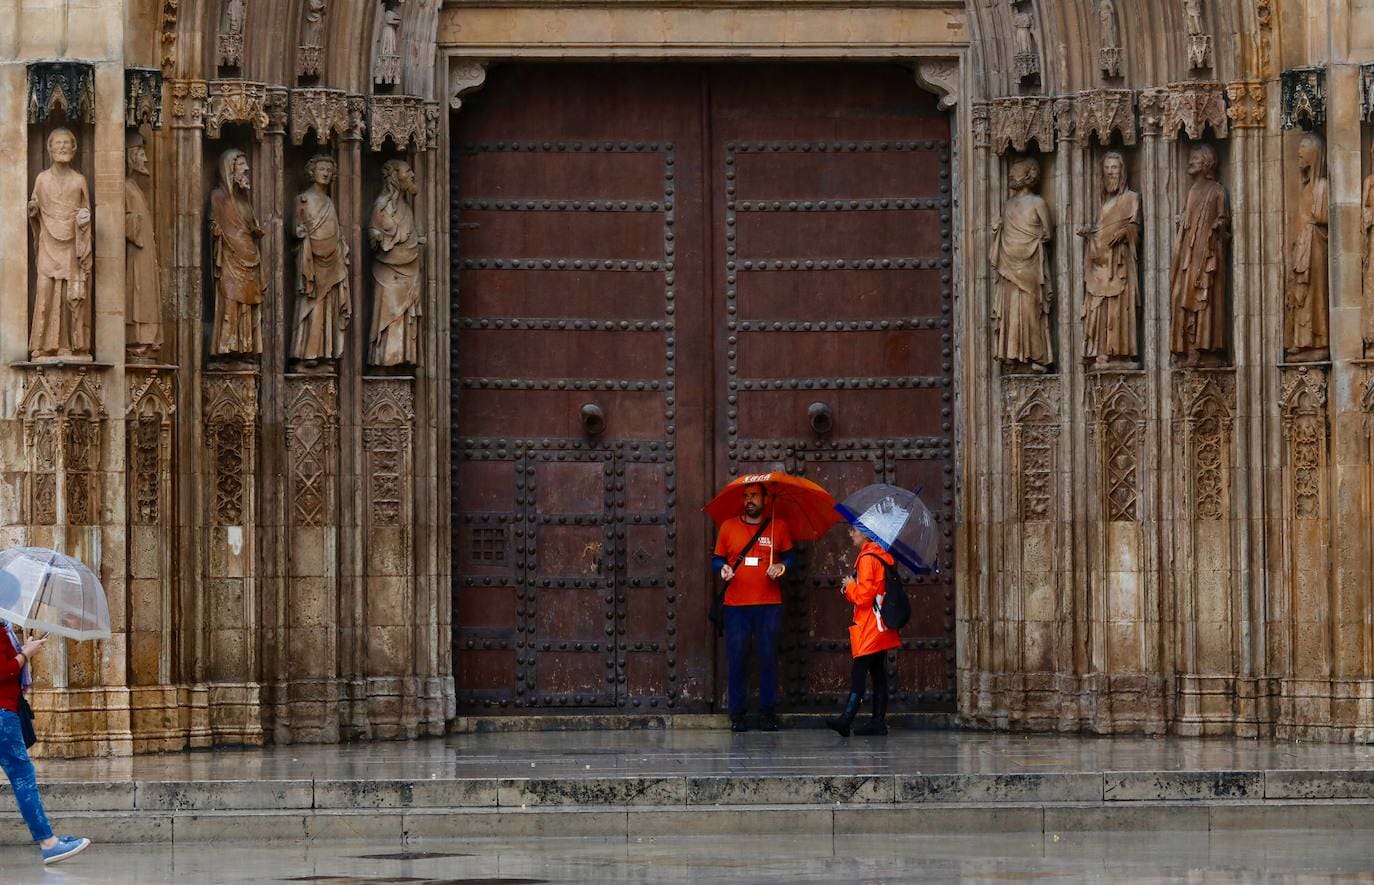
[210,148,267,355]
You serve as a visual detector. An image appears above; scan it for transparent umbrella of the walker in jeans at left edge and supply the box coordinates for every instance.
[0,547,110,640]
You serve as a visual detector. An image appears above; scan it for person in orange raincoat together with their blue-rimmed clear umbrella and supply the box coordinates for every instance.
[826,482,940,738]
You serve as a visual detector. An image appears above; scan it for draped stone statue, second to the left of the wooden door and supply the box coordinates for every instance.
[291,154,353,360]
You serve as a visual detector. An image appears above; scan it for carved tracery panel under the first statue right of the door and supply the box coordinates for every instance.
[1003,378,1059,522]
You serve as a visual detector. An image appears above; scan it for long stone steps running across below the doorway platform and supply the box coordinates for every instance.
[0,765,1374,844]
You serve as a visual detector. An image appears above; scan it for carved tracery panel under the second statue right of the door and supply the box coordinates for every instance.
[1088,372,1146,522]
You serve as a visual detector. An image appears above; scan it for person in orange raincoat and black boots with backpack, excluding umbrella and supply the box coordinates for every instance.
[826,526,901,738]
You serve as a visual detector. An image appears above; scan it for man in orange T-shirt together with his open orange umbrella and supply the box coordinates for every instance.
[706,471,838,731]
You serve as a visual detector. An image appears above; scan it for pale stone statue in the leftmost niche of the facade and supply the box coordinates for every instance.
[29,129,93,360]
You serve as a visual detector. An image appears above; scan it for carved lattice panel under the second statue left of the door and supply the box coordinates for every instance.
[286,377,338,526]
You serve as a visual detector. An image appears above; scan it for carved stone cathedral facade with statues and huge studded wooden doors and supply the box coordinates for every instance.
[0,0,1374,756]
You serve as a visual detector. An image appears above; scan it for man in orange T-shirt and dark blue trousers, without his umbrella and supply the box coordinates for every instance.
[710,485,791,731]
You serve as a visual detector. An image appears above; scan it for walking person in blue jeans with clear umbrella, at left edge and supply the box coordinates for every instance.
[0,547,110,864]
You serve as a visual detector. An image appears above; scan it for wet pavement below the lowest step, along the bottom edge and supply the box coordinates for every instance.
[0,831,1374,885]
